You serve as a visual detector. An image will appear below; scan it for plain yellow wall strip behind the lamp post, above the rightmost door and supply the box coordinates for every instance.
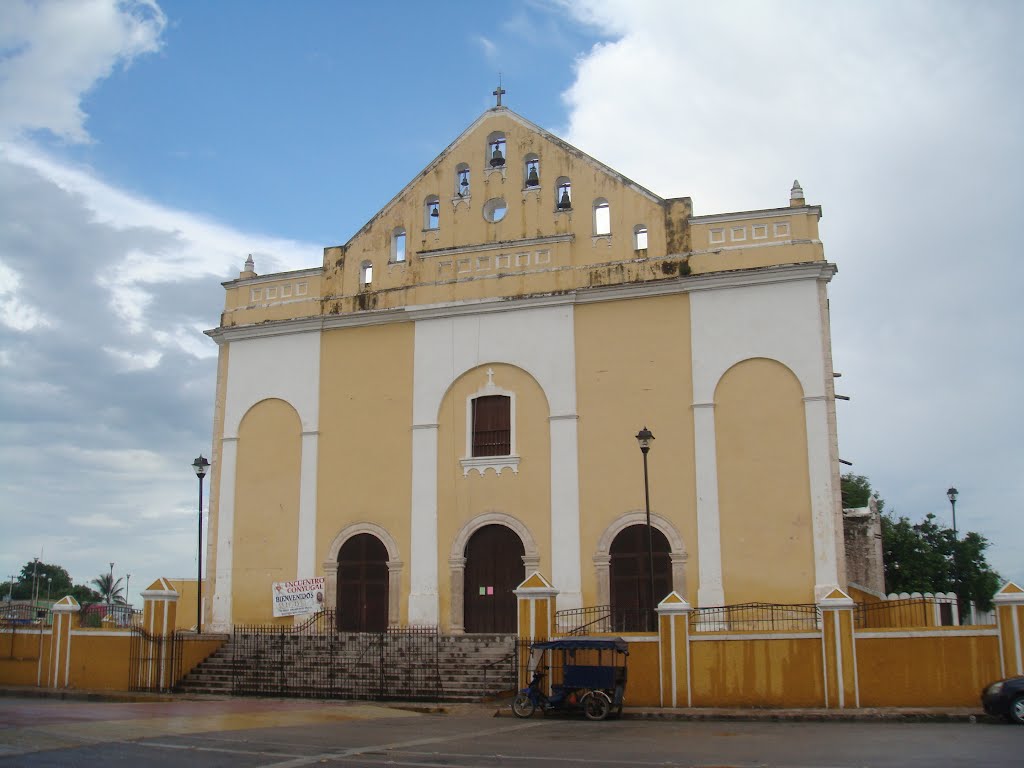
[574,295,698,605]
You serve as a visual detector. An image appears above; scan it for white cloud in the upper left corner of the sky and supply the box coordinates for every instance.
[0,0,167,142]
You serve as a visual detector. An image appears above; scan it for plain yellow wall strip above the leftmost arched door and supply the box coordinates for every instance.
[319,323,415,622]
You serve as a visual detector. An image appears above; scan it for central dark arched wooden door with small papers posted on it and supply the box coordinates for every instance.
[463,525,526,634]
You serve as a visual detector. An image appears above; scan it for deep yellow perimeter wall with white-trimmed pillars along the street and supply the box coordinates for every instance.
[0,589,1024,709]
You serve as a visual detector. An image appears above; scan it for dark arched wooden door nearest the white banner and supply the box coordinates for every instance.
[338,534,388,632]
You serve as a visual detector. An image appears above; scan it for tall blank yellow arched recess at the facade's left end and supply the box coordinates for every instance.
[231,398,302,624]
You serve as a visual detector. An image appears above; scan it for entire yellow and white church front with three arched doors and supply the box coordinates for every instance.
[206,105,846,633]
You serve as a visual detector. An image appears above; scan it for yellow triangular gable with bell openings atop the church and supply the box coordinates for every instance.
[343,108,666,270]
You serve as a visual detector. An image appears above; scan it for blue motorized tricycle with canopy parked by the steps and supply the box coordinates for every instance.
[512,636,630,720]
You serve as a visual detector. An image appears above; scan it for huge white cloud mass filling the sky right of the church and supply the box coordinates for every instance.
[563,0,1024,580]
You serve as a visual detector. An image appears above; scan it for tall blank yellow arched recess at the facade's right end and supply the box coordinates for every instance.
[715,357,814,604]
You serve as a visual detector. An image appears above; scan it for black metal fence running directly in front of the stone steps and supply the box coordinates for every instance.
[231,610,442,701]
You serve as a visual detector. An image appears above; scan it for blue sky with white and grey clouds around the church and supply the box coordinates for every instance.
[0,0,1024,600]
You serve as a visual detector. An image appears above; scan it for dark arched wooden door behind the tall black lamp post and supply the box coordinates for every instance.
[609,525,672,632]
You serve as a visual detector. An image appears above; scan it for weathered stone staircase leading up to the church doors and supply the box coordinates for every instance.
[176,633,517,702]
